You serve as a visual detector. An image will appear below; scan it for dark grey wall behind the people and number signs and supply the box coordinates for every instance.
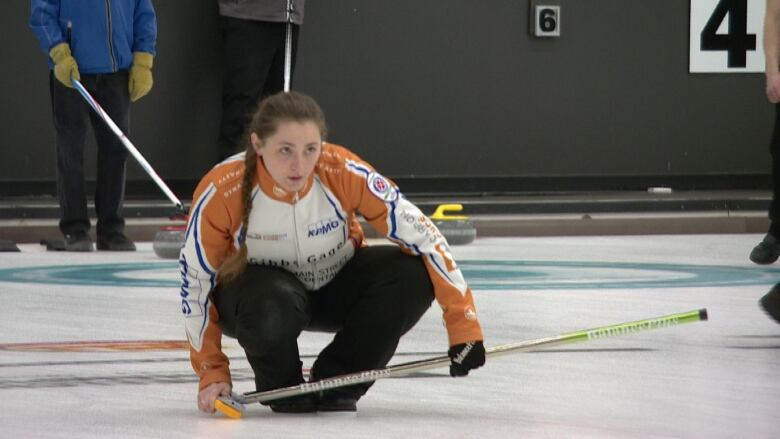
[0,0,773,197]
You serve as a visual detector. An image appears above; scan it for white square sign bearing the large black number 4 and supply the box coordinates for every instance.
[688,0,766,73]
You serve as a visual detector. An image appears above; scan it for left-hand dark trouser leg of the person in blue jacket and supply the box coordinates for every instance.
[49,73,91,235]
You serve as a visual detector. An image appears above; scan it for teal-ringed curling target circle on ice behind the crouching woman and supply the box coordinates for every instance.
[0,259,780,290]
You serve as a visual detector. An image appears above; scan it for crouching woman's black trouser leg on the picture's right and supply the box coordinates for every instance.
[307,246,434,396]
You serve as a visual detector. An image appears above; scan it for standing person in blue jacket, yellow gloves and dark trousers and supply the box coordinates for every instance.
[30,0,157,251]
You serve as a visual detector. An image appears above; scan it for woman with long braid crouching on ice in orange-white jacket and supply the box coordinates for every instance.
[179,92,485,413]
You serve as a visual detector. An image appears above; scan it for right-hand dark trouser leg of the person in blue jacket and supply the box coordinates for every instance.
[89,70,130,237]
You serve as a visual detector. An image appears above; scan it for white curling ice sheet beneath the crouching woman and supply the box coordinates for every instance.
[0,235,780,439]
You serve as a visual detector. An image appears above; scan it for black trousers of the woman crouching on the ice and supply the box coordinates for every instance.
[214,246,434,397]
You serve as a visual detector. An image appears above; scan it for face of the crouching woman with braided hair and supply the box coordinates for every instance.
[250,121,322,192]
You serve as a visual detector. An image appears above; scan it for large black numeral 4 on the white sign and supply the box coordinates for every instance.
[701,0,756,67]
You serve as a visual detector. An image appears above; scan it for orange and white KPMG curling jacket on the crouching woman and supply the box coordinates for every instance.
[179,143,483,389]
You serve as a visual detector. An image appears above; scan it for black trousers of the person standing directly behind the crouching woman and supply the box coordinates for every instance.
[218,17,297,160]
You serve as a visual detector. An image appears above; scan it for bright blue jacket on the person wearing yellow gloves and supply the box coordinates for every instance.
[30,0,157,74]
